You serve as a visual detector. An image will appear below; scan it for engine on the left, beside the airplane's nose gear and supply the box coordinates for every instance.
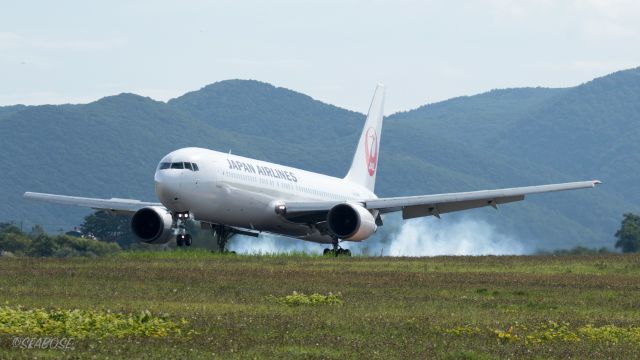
[131,206,173,244]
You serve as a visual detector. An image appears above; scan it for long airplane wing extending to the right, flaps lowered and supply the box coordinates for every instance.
[285,180,601,221]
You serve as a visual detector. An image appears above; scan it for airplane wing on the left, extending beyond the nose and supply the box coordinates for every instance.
[24,192,163,214]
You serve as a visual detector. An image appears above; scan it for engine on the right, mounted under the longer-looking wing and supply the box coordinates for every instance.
[327,203,378,241]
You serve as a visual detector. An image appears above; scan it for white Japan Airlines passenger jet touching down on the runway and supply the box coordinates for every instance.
[24,85,601,256]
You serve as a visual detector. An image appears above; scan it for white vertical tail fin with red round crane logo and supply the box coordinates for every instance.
[345,84,384,191]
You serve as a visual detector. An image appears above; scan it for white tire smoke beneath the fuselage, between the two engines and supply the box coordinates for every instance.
[228,234,323,254]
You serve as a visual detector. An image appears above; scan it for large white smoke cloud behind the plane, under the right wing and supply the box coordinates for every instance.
[389,219,528,256]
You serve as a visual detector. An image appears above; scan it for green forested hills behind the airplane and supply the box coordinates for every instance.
[0,68,640,249]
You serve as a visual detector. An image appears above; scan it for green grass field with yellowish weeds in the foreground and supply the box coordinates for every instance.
[0,250,640,359]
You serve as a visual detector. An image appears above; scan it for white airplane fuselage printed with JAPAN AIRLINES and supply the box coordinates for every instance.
[155,148,376,243]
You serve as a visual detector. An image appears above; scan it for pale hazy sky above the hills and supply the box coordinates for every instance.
[0,0,640,113]
